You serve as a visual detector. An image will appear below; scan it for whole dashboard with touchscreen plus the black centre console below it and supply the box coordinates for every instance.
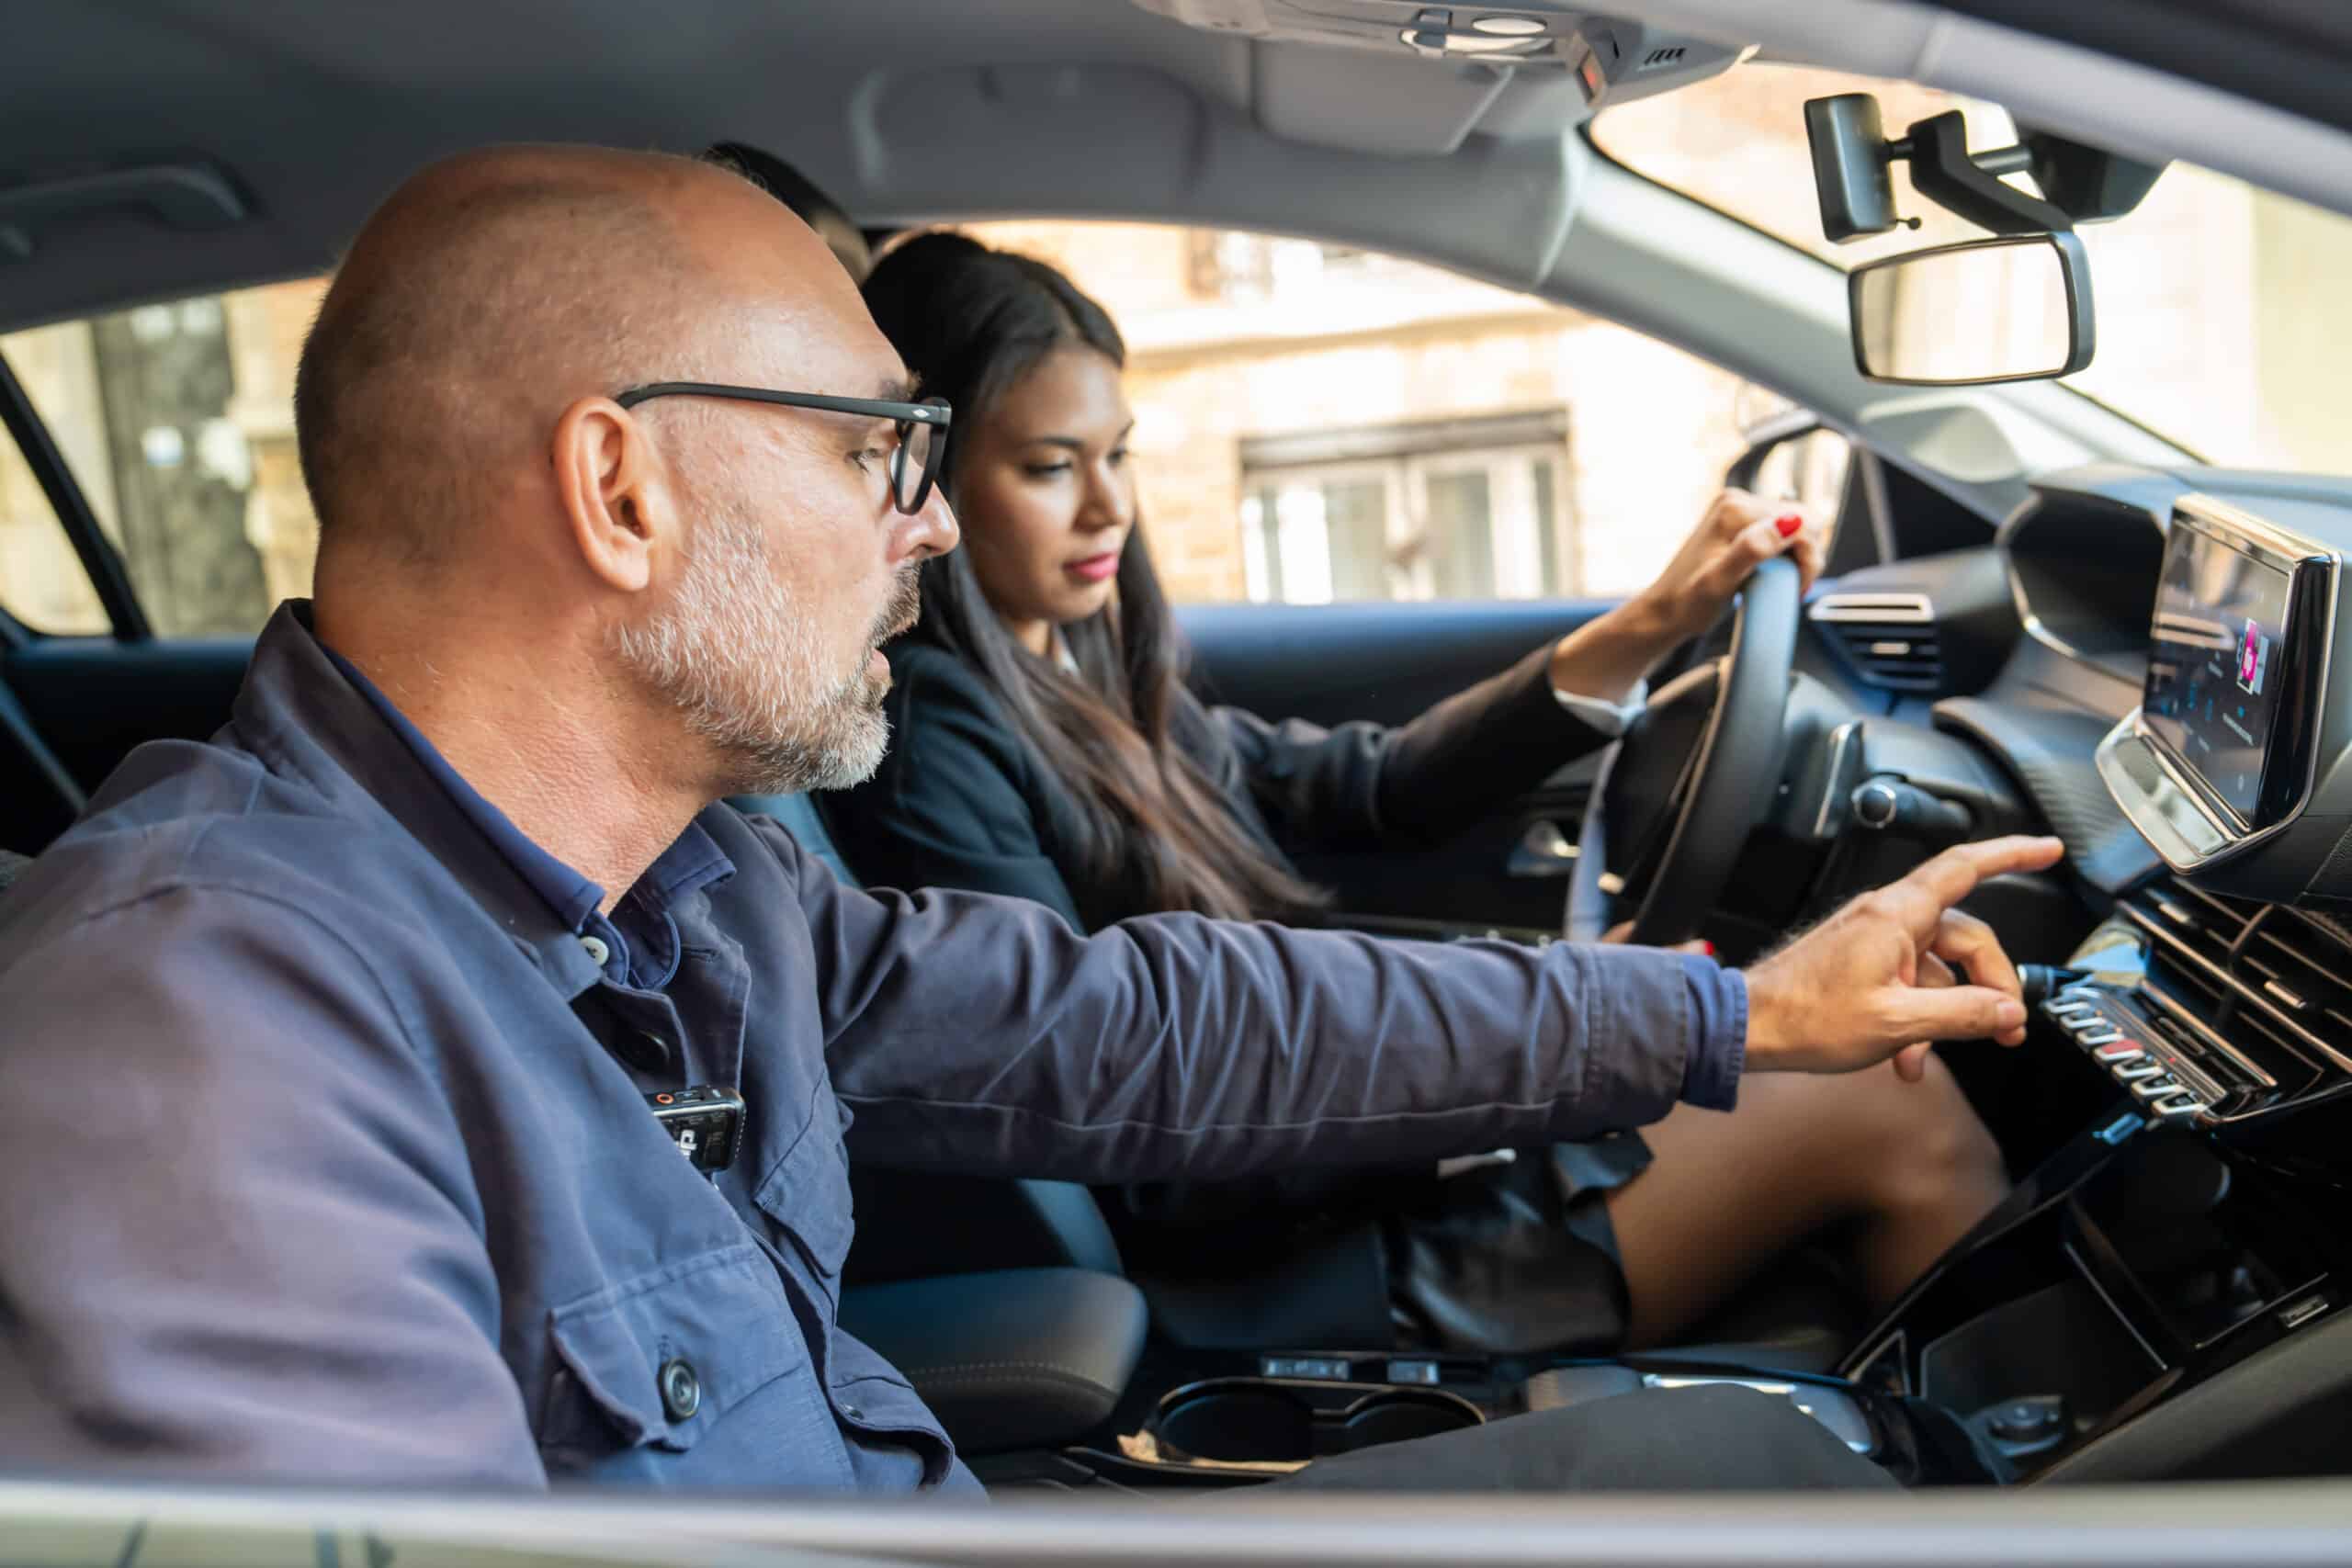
[1782,466,2352,1483]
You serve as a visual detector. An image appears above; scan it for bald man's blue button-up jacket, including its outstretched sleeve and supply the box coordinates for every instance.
[0,604,1746,1491]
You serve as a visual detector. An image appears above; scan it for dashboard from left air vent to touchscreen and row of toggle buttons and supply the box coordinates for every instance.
[1811,466,2352,1142]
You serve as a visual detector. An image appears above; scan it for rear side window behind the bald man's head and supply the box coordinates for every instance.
[0,280,322,637]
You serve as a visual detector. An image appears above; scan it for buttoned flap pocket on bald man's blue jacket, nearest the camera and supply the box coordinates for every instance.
[538,1244,819,1472]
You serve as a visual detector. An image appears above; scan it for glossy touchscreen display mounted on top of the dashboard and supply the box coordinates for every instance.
[2141,520,2293,818]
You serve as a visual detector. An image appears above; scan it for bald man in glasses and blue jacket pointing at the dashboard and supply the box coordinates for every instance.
[0,148,2055,1493]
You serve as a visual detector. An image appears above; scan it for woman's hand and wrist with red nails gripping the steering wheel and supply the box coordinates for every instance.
[1553,489,1827,703]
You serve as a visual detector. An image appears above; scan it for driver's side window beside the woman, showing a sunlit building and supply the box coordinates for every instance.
[971,223,1839,604]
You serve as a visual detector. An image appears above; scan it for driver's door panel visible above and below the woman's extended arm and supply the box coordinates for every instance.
[1179,600,1611,936]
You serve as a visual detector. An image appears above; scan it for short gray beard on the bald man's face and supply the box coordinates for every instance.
[612,508,917,795]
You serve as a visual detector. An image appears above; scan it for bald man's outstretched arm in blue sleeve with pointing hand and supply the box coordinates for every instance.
[783,822,2058,1182]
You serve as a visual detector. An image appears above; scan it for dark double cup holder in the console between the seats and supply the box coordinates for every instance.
[1152,1378,1487,1464]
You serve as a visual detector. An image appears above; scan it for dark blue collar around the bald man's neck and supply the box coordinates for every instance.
[232,600,736,997]
